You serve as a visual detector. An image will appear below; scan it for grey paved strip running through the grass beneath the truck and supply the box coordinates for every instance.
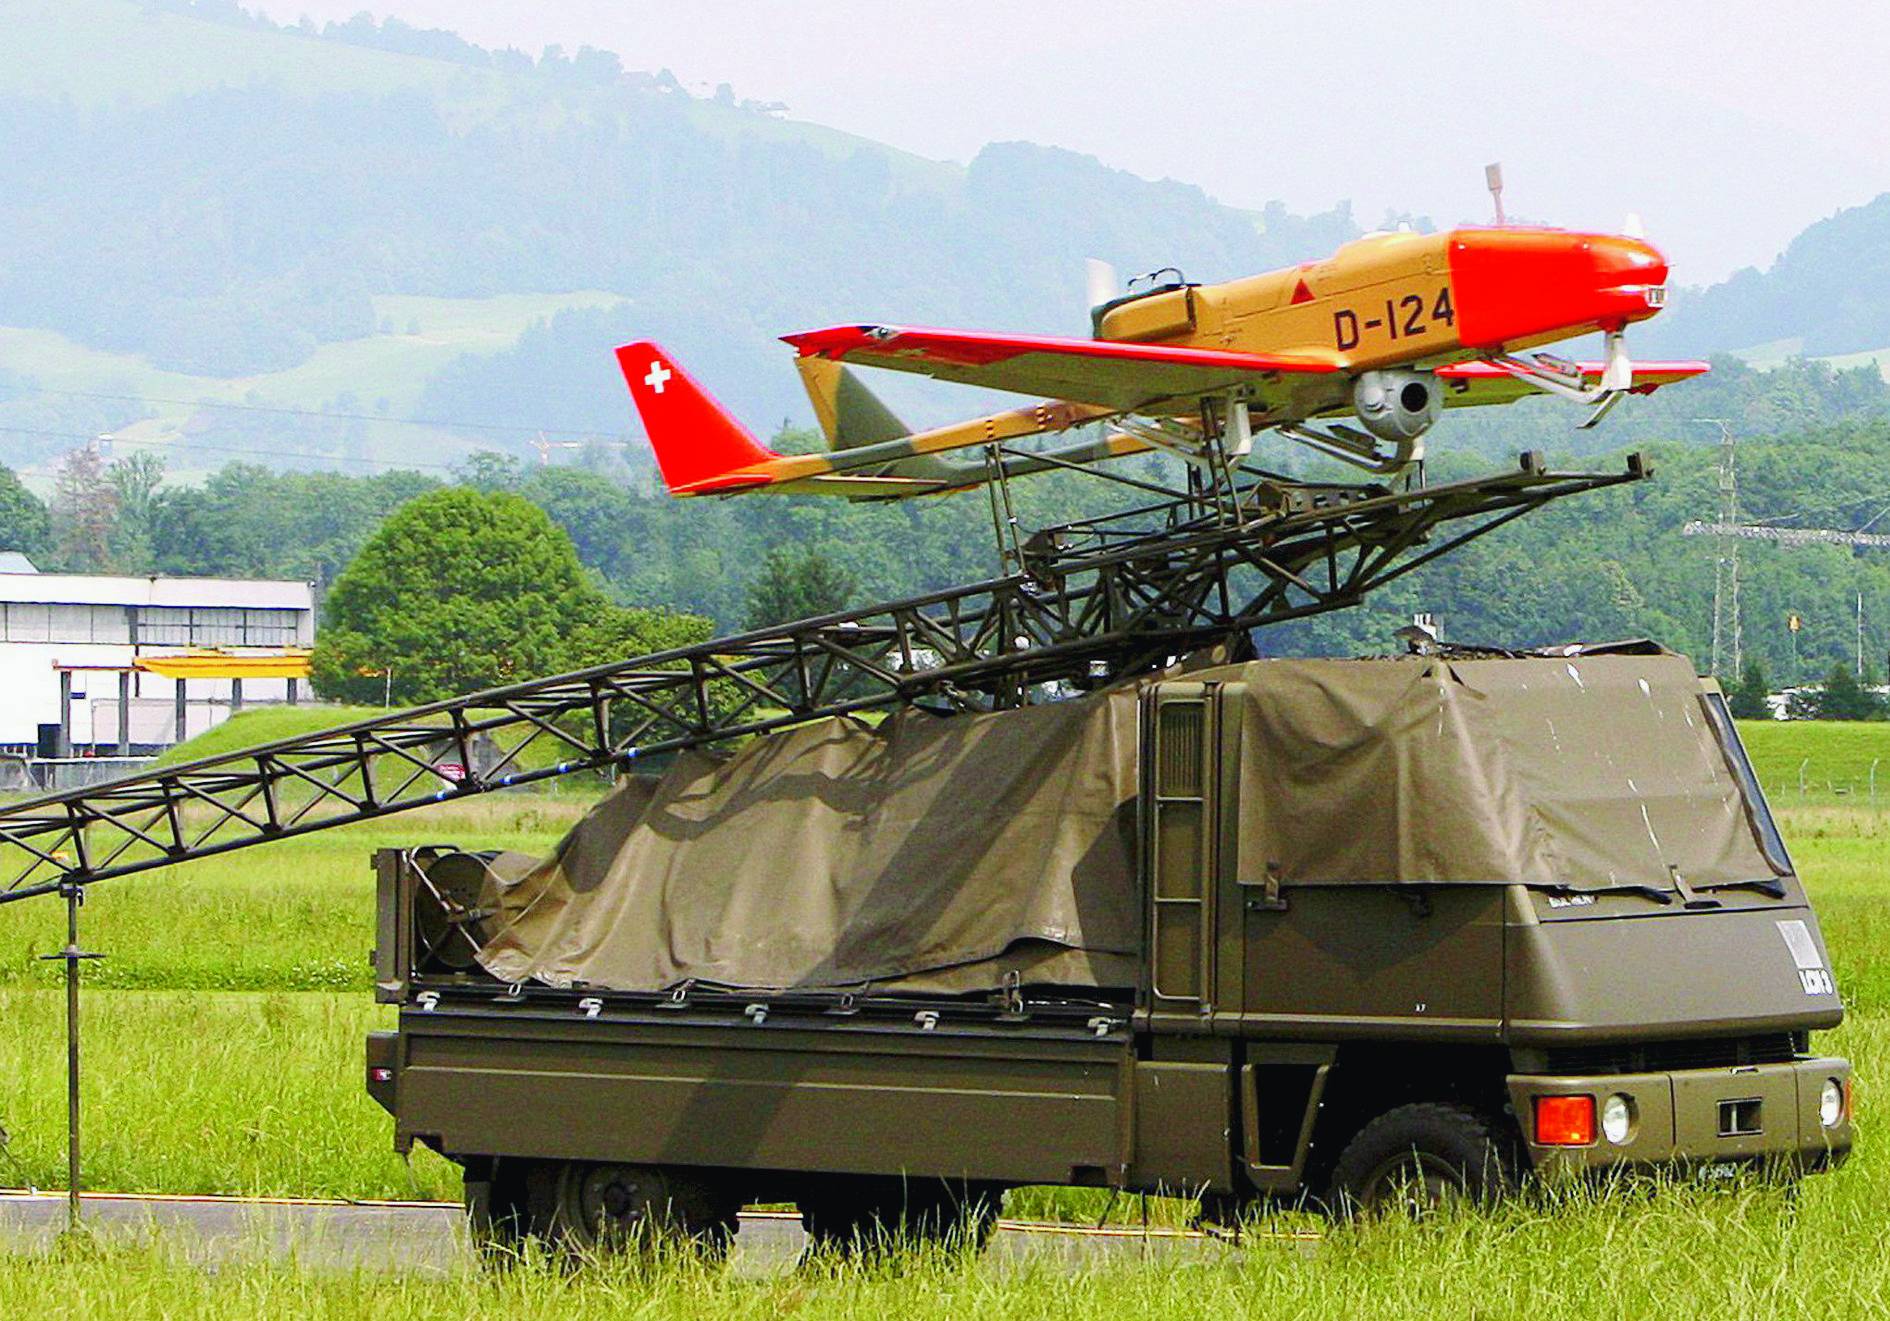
[0,1192,1312,1276]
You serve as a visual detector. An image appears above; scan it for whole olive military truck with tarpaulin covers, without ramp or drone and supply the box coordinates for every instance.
[367,644,1852,1245]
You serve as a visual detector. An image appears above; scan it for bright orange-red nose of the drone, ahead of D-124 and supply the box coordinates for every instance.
[1450,229,1667,350]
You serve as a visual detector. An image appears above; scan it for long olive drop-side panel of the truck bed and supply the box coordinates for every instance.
[399,1005,1126,1185]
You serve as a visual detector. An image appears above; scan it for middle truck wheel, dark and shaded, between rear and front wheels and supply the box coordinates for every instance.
[799,1177,1002,1257]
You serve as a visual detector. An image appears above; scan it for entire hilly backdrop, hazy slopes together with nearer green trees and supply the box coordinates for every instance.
[11,0,1890,699]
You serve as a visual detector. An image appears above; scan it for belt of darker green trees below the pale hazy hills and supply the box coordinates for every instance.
[14,398,1890,684]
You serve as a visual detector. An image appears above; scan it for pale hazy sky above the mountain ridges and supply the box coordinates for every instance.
[246,0,1890,283]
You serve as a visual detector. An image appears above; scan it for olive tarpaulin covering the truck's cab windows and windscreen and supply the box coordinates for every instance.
[1227,656,1775,890]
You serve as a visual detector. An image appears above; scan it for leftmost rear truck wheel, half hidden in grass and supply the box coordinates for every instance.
[554,1160,741,1257]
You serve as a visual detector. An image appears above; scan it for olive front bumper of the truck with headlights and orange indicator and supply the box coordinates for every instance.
[1508,1058,1852,1179]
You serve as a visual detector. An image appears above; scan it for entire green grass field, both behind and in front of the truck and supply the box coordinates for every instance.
[0,726,1890,1321]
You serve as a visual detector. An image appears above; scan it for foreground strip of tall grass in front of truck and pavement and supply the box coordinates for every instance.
[0,1181,1890,1321]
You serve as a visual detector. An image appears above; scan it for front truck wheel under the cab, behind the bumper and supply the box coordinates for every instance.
[1325,1102,1514,1217]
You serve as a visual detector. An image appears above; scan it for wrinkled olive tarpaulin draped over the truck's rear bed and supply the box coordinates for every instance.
[480,692,1142,990]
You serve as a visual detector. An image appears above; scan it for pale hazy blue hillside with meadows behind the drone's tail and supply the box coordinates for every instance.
[0,0,1357,472]
